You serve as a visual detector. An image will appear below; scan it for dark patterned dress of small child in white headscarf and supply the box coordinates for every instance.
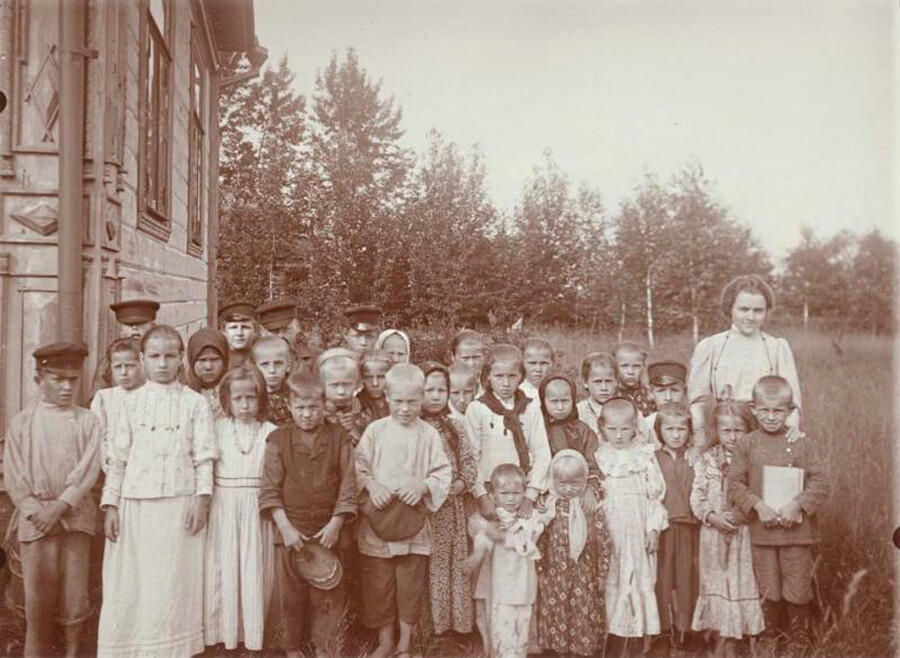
[537,498,610,656]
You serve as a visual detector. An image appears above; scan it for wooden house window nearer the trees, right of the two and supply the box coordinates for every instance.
[188,27,209,256]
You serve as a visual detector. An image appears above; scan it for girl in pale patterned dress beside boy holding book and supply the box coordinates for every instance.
[691,401,764,658]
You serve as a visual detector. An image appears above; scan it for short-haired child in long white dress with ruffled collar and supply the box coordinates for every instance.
[597,398,668,656]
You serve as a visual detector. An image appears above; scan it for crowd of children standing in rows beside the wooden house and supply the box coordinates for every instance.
[4,301,828,658]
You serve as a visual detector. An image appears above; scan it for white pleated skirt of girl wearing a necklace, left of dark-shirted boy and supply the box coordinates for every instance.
[203,487,275,651]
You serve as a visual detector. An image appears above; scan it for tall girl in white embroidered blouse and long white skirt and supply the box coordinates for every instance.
[97,325,216,658]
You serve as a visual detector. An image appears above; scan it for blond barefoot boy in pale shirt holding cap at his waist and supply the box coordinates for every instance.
[356,364,451,658]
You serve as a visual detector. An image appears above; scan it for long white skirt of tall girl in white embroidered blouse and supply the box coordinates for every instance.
[97,496,206,658]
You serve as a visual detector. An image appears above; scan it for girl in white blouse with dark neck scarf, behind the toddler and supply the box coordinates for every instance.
[466,344,550,519]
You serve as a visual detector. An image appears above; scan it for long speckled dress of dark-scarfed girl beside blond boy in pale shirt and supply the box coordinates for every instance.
[426,417,478,635]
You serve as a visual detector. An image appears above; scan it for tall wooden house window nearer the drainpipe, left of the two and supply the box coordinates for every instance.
[138,0,172,239]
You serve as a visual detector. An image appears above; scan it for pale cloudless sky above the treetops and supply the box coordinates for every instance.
[255,0,900,262]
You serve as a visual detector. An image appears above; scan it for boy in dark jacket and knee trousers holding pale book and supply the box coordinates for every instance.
[727,375,829,639]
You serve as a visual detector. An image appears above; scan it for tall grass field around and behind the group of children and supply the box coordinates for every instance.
[0,329,898,658]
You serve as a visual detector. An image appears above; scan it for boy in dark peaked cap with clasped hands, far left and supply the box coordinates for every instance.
[3,343,101,658]
